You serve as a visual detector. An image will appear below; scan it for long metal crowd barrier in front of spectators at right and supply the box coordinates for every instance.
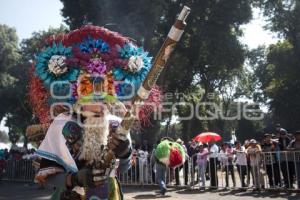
[119,151,300,190]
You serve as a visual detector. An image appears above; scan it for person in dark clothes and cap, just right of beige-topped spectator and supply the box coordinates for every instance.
[261,133,281,187]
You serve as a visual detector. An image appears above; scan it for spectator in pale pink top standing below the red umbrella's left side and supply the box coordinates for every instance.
[197,142,209,189]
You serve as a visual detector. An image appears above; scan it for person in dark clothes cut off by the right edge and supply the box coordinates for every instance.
[288,130,300,189]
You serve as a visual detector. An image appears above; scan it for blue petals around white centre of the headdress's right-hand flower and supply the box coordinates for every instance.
[113,44,152,90]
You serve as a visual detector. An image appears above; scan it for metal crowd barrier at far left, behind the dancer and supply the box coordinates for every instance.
[1,160,35,182]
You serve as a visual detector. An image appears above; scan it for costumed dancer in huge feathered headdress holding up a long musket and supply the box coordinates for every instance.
[29,7,190,200]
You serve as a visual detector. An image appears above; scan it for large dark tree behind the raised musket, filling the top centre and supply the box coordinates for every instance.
[61,0,252,140]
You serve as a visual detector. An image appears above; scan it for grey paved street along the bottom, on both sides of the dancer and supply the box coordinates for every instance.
[0,182,300,200]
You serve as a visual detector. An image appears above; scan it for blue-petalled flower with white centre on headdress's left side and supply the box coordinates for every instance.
[35,42,79,87]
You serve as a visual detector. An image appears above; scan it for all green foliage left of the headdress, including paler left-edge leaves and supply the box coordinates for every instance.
[0,25,67,144]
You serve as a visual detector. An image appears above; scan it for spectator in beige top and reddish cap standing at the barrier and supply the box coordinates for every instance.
[246,139,264,191]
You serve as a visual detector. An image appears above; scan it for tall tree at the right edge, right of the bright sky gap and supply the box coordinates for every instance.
[250,0,300,130]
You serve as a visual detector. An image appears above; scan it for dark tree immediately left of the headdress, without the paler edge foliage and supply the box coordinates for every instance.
[0,26,66,145]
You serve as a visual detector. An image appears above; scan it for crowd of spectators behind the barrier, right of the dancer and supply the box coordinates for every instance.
[125,125,300,190]
